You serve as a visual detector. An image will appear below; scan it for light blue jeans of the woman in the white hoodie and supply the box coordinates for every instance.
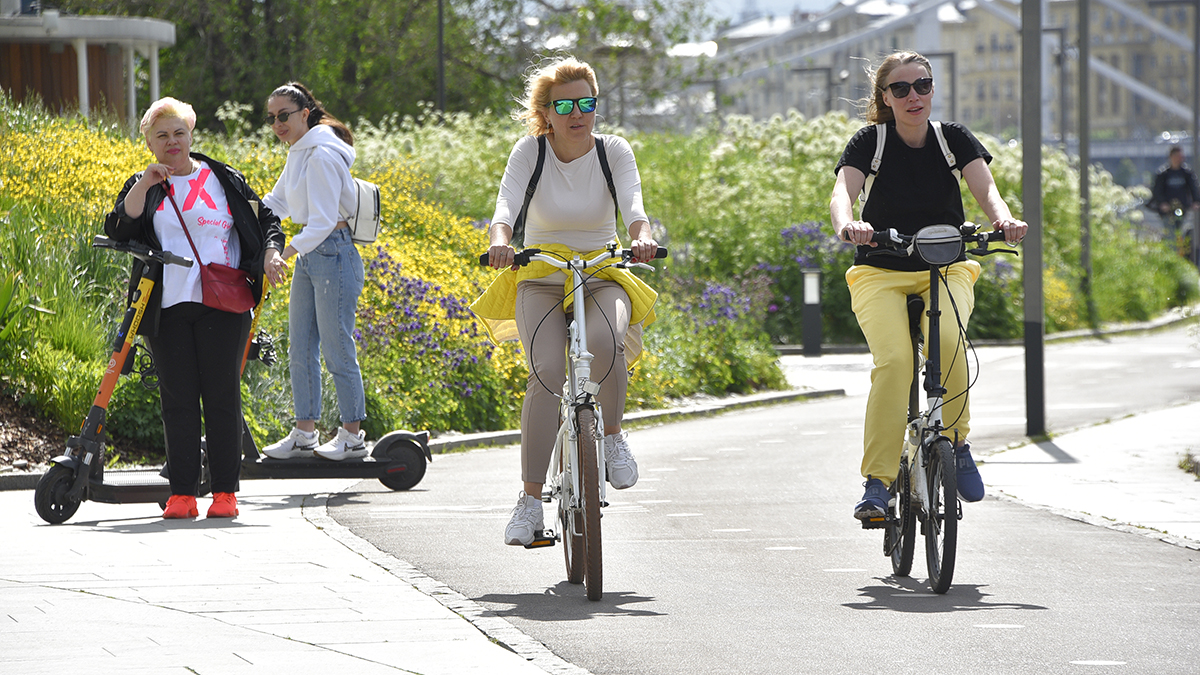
[288,228,367,424]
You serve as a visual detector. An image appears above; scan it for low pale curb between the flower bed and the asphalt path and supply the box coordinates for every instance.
[0,389,846,490]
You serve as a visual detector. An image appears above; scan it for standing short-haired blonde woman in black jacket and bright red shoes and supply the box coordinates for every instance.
[104,97,283,518]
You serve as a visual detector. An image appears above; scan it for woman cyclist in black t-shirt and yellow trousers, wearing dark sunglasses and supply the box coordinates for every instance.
[829,52,1028,520]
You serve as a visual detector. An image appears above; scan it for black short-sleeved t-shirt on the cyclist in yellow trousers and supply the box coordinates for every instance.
[834,121,991,271]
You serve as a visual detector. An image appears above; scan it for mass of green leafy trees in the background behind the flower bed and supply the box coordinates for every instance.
[60,0,710,130]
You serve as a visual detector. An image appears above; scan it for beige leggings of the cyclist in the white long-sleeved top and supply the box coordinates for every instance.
[516,279,631,483]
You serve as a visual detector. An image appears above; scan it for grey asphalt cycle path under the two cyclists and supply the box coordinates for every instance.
[329,328,1200,675]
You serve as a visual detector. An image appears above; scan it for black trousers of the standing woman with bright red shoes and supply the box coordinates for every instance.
[150,303,250,496]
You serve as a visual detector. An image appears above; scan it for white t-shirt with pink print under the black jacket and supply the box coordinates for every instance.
[154,162,241,307]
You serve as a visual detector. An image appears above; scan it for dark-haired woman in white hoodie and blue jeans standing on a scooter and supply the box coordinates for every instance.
[263,82,367,461]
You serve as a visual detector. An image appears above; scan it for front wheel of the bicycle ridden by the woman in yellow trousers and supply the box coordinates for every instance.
[925,438,959,593]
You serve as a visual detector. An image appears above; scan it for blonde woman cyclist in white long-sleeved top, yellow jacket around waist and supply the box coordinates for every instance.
[472,58,658,545]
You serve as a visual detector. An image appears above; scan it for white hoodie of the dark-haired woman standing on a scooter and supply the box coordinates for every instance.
[263,124,355,256]
